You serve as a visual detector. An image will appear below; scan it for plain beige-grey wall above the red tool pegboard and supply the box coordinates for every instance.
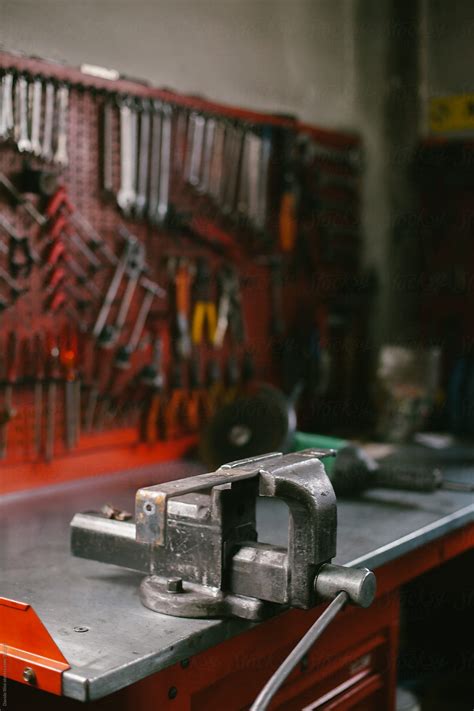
[0,0,354,127]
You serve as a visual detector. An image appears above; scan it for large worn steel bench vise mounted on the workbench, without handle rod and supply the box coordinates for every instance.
[71,449,375,620]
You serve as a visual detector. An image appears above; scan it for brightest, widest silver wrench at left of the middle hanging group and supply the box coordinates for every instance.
[117,101,137,216]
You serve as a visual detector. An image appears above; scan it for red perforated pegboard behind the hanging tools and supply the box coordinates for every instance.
[0,47,366,489]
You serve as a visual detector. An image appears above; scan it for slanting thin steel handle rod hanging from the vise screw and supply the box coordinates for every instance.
[249,592,349,711]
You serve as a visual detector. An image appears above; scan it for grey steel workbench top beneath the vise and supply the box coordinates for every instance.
[0,450,474,701]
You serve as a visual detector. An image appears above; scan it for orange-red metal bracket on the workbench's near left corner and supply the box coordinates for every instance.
[0,597,70,694]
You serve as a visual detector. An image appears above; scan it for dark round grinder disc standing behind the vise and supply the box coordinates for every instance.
[199,384,296,468]
